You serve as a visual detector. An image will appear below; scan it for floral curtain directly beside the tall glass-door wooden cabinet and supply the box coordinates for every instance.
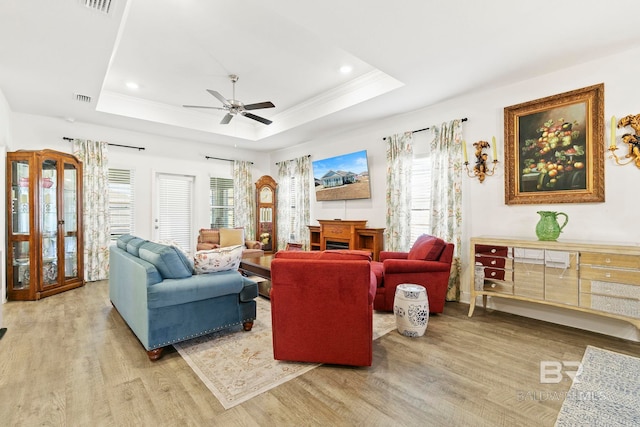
[73,139,111,282]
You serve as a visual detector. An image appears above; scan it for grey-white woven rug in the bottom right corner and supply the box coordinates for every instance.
[556,346,640,427]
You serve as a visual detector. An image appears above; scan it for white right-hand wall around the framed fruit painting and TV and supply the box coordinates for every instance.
[273,49,640,340]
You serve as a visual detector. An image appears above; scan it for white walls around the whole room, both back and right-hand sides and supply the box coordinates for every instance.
[8,49,640,340]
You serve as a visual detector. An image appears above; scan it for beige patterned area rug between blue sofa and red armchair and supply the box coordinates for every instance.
[174,298,396,409]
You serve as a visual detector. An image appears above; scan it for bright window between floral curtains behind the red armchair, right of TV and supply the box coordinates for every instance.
[411,155,431,243]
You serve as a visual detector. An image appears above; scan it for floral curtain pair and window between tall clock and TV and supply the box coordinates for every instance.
[277,156,311,249]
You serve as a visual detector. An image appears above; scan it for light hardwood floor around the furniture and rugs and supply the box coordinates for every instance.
[0,281,640,427]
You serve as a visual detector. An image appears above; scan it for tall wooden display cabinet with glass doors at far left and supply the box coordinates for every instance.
[6,150,85,300]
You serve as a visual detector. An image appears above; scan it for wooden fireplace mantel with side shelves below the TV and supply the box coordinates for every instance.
[308,219,384,261]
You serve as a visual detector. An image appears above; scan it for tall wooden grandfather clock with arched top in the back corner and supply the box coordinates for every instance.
[256,175,278,254]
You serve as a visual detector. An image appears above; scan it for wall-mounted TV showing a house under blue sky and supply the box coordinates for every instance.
[312,150,371,202]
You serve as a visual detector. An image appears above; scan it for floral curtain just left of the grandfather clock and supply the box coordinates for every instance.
[233,160,256,240]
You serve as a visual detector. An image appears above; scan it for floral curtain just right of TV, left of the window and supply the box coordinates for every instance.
[385,132,413,252]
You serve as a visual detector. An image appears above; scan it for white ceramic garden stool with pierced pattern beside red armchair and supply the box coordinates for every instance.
[393,283,429,337]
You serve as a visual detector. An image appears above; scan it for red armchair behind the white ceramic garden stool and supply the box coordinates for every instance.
[371,234,453,313]
